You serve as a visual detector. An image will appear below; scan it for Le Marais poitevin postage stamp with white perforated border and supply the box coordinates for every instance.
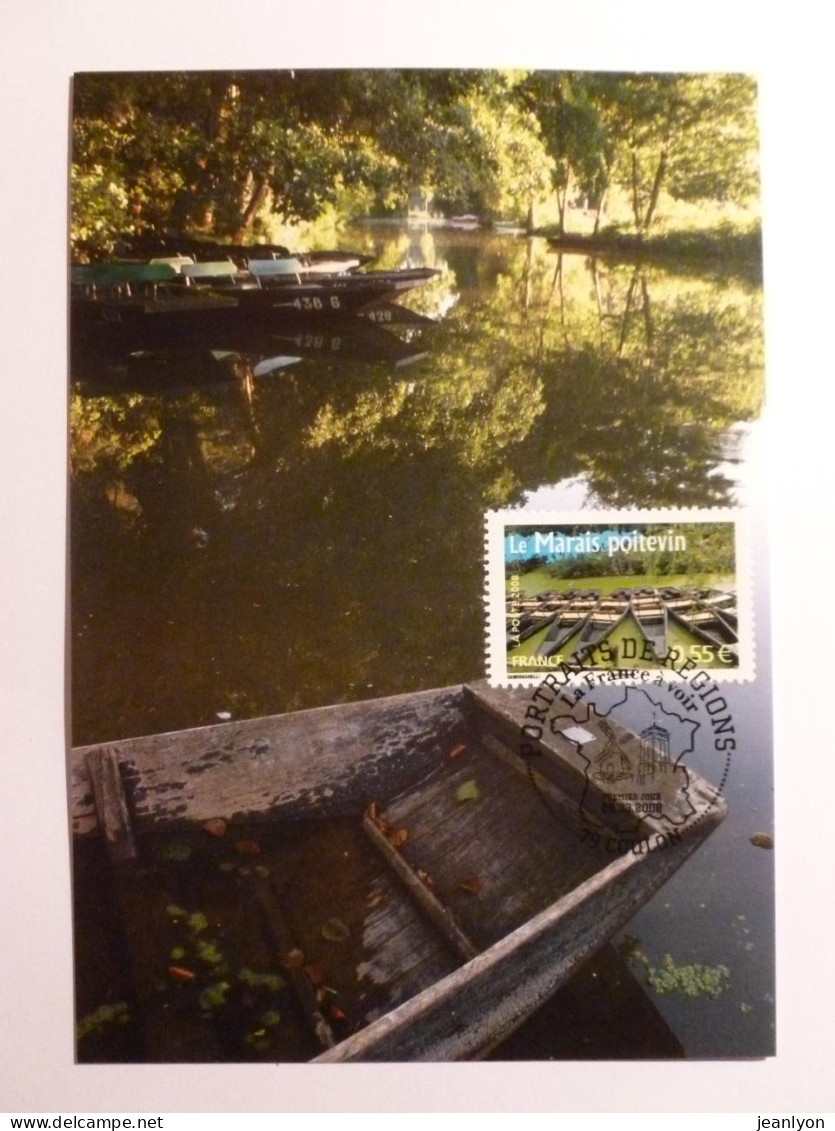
[485,509,756,687]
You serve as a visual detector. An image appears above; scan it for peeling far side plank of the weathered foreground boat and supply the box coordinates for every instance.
[70,688,466,835]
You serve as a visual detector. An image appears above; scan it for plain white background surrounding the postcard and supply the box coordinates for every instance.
[0,0,835,1112]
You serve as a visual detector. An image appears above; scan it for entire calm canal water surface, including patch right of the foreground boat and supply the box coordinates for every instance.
[71,226,774,1056]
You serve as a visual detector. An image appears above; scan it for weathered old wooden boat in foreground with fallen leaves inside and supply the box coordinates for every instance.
[70,684,724,1062]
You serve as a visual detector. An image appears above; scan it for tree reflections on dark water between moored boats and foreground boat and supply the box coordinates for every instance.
[72,238,761,741]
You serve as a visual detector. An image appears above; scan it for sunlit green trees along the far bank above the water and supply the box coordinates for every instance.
[71,70,758,259]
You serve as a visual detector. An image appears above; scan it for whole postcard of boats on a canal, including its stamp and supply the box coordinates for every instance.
[68,69,775,1063]
